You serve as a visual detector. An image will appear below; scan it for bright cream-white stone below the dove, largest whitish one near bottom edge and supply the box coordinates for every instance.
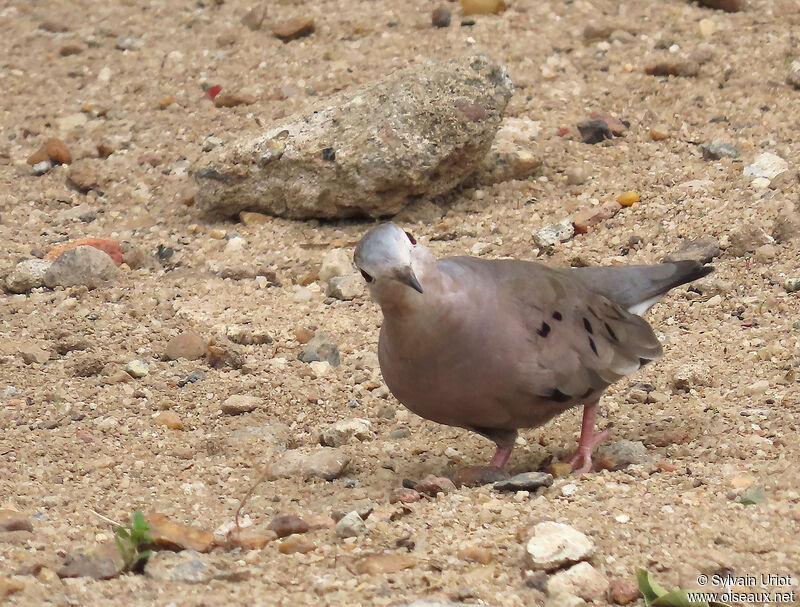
[525,521,594,571]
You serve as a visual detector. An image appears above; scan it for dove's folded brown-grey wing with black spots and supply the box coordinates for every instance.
[446,258,663,403]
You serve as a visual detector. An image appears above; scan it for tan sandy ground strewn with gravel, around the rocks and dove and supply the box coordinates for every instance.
[0,0,800,606]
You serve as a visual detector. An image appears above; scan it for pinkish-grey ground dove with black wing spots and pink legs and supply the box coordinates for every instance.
[355,223,713,472]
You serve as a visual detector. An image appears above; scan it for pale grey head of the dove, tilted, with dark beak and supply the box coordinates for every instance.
[353,223,422,293]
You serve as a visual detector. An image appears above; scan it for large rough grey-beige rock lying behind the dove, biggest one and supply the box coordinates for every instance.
[194,55,513,218]
